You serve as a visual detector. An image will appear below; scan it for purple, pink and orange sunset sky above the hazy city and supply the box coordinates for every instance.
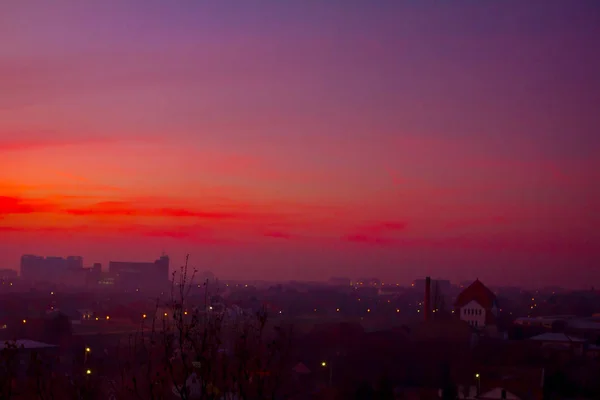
[0,0,600,287]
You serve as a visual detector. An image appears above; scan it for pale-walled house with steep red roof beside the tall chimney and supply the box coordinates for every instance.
[454,279,498,329]
